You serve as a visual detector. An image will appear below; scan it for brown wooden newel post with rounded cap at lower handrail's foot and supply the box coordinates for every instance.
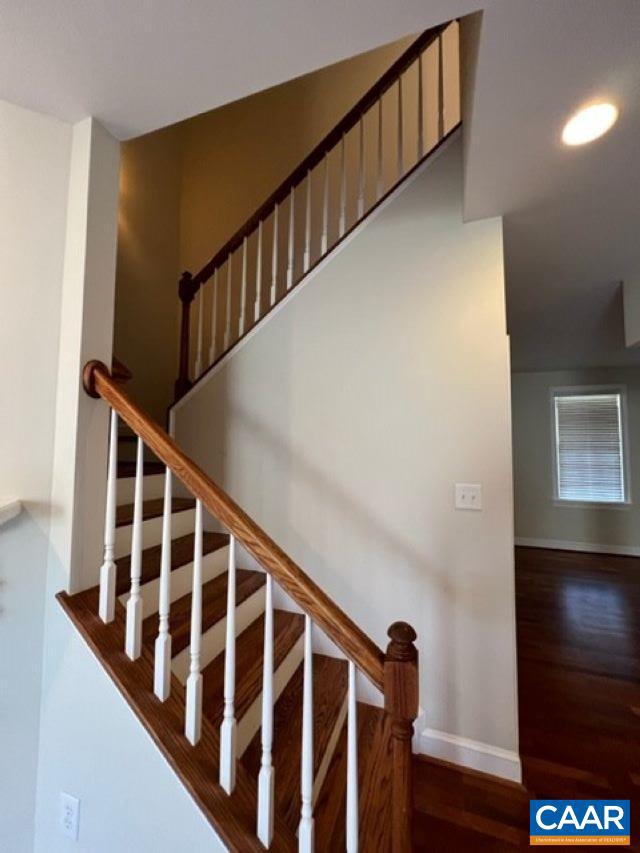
[384,622,418,853]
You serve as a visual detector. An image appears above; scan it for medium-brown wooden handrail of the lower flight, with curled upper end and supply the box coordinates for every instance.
[83,361,385,691]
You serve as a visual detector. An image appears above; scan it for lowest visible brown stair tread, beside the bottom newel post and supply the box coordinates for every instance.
[314,702,393,853]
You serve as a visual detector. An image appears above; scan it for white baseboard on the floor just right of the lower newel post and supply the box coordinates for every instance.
[414,729,522,782]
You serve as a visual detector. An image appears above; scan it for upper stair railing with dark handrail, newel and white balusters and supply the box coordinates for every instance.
[175,22,460,399]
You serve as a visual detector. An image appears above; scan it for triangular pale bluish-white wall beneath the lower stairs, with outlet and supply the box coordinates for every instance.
[33,603,225,853]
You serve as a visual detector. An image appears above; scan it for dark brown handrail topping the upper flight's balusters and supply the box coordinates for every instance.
[188,24,448,290]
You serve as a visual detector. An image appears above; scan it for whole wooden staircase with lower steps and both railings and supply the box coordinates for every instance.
[58,25,459,853]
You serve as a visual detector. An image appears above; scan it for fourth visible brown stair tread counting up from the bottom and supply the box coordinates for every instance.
[142,569,265,656]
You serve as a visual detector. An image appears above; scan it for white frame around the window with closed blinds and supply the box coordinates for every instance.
[549,385,632,510]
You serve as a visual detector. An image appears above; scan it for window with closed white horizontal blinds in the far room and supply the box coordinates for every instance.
[553,389,627,504]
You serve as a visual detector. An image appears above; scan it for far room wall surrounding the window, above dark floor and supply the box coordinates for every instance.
[512,368,640,554]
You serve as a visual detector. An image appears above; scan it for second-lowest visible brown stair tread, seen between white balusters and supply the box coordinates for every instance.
[242,654,348,832]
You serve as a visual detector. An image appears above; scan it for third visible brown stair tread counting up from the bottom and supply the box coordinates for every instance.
[202,610,304,725]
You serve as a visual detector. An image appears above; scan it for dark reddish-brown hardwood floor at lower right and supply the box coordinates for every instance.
[415,548,640,851]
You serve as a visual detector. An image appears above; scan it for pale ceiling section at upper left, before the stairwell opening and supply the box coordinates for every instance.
[0,0,484,139]
